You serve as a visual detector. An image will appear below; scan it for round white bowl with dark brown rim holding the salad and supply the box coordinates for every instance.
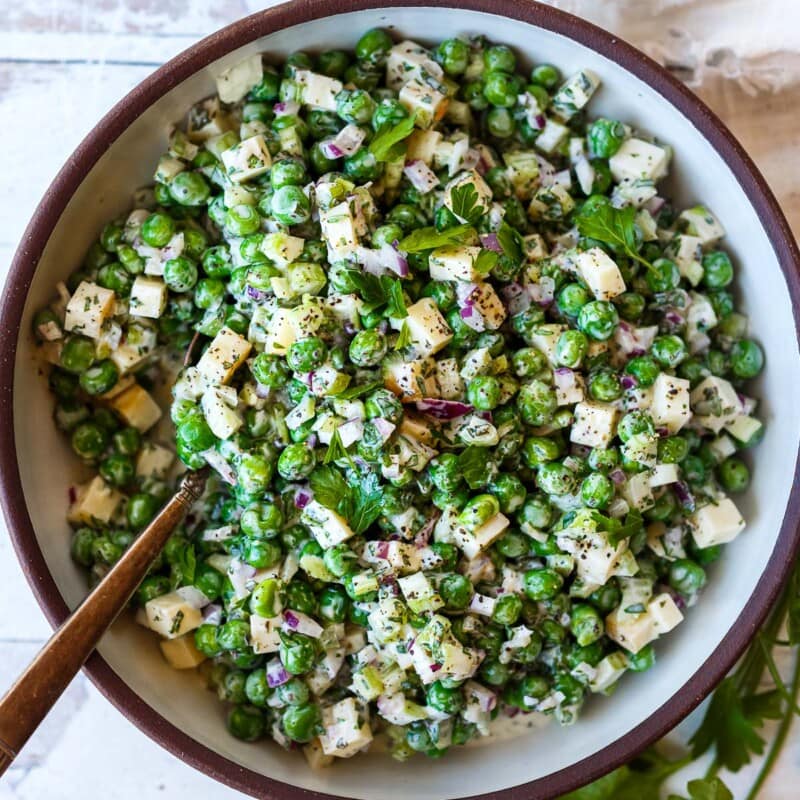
[0,0,800,800]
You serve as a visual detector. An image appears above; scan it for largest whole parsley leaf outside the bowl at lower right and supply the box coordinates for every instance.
[689,676,764,772]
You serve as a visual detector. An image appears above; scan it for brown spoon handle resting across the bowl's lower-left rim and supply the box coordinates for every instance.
[0,472,206,775]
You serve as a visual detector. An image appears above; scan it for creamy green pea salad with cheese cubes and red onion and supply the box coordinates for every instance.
[34,29,764,767]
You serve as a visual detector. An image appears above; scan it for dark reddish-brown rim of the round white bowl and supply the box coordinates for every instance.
[0,0,800,800]
